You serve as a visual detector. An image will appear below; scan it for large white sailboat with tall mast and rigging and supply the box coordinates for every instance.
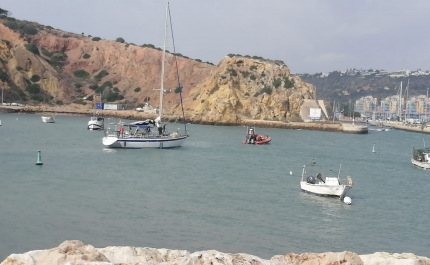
[103,0,188,149]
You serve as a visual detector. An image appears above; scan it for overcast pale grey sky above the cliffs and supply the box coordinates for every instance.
[0,0,430,73]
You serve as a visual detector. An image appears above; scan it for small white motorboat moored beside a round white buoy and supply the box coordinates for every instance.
[300,162,353,202]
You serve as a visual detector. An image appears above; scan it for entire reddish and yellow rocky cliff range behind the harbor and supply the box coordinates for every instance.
[0,17,315,124]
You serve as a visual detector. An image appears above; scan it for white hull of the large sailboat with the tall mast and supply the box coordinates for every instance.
[103,136,187,149]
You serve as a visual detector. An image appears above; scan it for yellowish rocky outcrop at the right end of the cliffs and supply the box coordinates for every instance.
[178,56,315,123]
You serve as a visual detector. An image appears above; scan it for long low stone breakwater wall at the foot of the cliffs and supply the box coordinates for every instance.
[0,106,368,134]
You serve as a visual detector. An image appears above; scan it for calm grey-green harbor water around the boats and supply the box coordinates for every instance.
[0,114,430,260]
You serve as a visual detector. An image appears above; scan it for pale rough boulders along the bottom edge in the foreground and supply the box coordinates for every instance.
[0,240,430,265]
